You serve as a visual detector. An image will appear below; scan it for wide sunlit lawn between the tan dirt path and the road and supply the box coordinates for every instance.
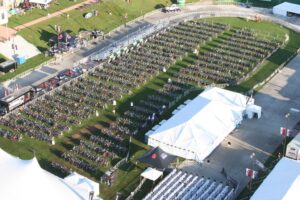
[18,0,195,51]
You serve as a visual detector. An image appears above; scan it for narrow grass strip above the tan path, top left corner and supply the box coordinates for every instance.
[8,0,84,28]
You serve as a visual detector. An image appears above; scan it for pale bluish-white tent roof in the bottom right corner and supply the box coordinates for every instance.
[250,157,300,200]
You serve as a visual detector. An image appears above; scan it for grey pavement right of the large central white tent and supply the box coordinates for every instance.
[181,55,300,197]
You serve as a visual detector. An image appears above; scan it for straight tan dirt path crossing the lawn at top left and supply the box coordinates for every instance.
[14,0,96,31]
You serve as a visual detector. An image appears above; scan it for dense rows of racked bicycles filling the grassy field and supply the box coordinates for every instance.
[0,21,280,177]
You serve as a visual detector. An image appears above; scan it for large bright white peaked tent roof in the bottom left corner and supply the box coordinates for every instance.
[0,149,99,200]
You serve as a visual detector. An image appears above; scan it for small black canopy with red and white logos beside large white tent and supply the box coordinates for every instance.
[139,147,176,169]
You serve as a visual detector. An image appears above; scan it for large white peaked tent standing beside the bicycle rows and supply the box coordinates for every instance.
[146,88,248,161]
